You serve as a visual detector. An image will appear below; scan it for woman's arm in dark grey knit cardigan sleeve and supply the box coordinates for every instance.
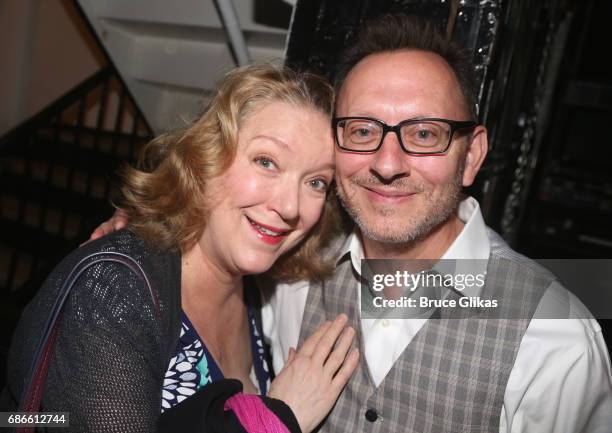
[14,256,169,432]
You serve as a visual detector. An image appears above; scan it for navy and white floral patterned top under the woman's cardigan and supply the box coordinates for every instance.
[161,307,270,413]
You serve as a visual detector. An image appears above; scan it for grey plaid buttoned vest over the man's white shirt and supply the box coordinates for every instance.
[300,231,554,433]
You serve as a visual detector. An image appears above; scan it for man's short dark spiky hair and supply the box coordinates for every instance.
[334,13,477,119]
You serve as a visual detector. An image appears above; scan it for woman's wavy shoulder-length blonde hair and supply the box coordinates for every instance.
[118,65,338,281]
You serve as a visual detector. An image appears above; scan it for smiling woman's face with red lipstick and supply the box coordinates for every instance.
[200,101,334,275]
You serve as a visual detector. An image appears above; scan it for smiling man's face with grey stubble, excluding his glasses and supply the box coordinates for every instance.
[336,51,486,248]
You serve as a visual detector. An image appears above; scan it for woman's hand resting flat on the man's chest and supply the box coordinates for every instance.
[268,314,359,433]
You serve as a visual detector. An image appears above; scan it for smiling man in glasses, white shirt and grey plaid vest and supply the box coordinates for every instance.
[263,11,612,433]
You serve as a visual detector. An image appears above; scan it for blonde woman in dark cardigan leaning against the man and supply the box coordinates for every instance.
[7,66,357,432]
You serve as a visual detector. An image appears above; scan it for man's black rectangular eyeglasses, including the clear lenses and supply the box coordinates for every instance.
[332,117,477,155]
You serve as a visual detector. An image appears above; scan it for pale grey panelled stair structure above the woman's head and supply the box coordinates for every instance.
[77,0,292,133]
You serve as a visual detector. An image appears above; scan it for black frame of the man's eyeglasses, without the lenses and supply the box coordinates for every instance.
[332,116,478,155]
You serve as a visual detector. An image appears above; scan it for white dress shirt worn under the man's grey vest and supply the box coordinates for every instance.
[262,198,612,433]
